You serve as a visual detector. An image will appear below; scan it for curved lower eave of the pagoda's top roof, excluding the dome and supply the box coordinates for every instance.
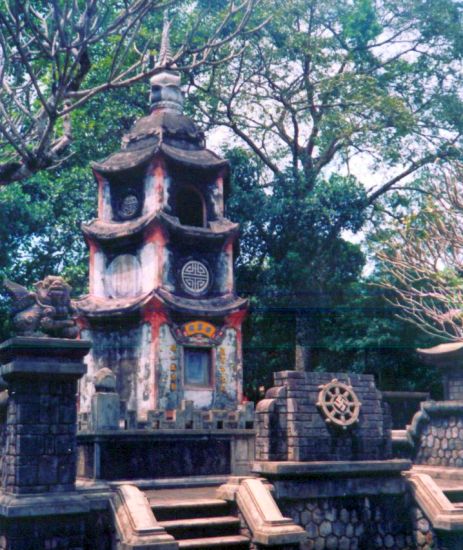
[92,142,228,176]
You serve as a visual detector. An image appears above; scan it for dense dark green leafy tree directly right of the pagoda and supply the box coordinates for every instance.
[228,149,365,380]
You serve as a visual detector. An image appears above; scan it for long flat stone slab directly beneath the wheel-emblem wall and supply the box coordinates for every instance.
[252,459,412,478]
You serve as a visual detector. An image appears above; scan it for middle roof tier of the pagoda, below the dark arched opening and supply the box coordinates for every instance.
[82,212,239,242]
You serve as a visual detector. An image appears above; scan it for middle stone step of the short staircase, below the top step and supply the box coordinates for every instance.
[159,516,240,540]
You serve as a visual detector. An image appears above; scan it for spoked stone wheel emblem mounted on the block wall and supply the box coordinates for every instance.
[317,378,362,430]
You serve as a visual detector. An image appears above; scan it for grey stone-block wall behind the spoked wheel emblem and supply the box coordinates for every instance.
[256,371,391,461]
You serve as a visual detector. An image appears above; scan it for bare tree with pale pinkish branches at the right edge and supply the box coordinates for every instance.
[375,165,463,341]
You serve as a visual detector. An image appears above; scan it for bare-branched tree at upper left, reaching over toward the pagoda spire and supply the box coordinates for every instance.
[0,0,259,184]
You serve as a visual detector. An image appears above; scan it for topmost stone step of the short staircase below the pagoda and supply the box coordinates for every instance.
[150,498,230,521]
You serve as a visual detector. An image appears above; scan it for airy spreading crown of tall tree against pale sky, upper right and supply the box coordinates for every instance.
[190,0,463,194]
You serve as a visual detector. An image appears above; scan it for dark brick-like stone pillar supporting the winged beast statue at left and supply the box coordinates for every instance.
[0,337,90,495]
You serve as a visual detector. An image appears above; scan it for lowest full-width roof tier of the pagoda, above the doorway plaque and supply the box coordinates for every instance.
[74,288,248,319]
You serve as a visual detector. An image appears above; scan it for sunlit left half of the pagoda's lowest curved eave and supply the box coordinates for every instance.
[74,291,154,319]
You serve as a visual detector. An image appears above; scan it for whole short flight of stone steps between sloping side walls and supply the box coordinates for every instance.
[148,488,250,550]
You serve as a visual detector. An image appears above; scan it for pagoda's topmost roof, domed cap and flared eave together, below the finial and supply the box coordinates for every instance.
[92,111,228,176]
